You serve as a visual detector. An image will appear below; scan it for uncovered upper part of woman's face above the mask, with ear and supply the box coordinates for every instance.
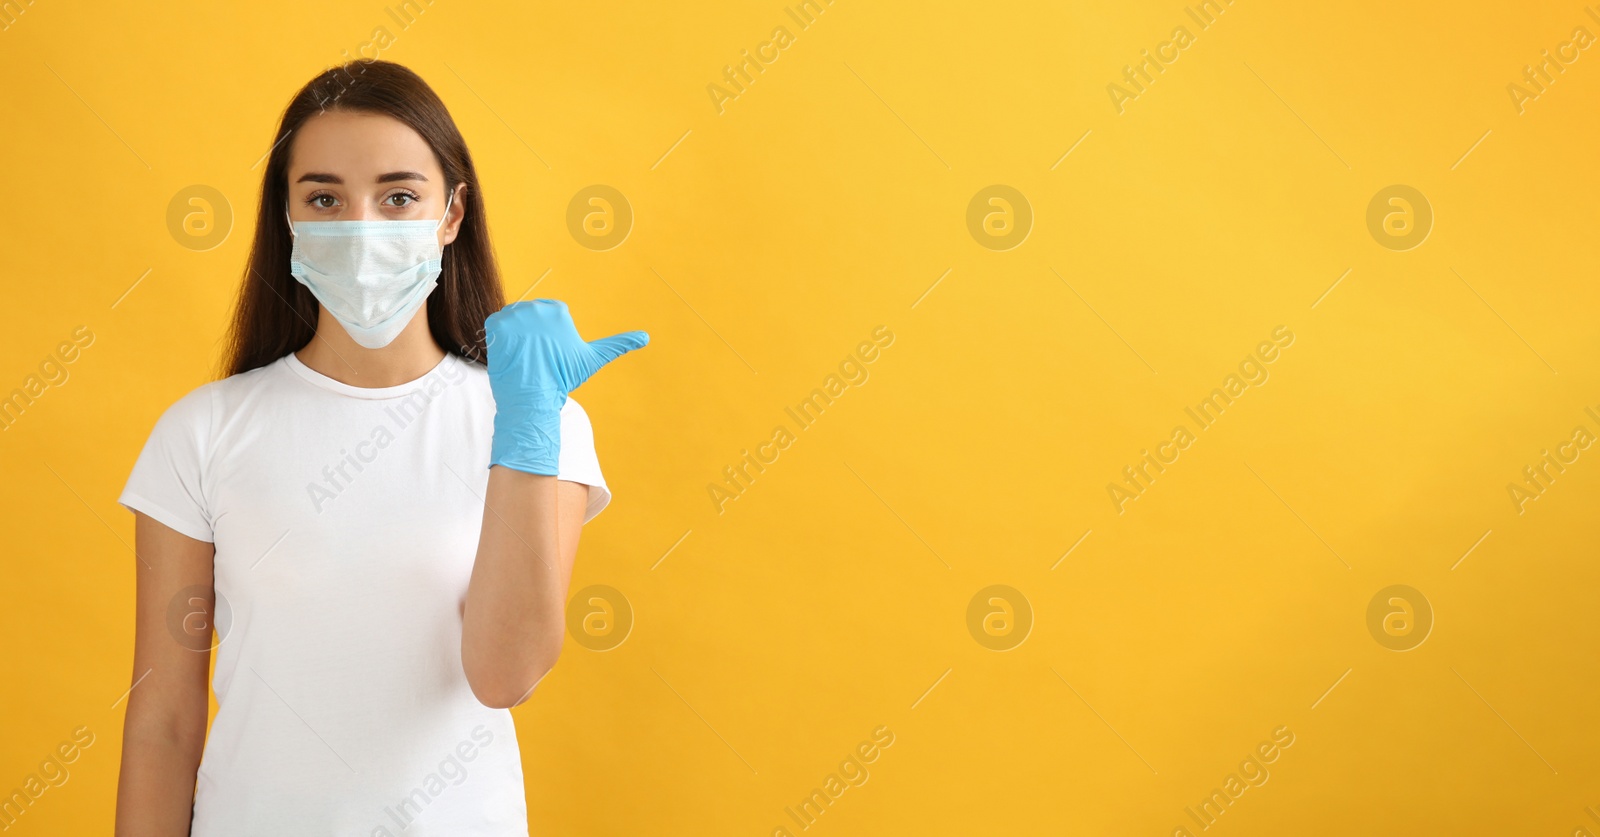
[288,110,466,246]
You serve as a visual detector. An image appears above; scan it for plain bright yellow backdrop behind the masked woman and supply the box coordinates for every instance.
[0,0,1600,835]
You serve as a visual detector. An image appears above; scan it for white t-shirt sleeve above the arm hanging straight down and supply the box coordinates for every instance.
[117,384,214,543]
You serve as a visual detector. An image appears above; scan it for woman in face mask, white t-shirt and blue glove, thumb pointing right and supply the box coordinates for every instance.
[117,61,648,837]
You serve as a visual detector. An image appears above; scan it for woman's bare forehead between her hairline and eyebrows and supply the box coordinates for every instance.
[290,110,443,182]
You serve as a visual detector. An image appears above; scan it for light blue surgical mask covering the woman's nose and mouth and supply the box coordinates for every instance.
[283,192,456,349]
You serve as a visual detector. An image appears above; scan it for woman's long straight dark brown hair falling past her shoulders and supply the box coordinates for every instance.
[222,59,506,376]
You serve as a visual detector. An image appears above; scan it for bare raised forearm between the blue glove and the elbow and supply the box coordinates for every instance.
[461,466,589,709]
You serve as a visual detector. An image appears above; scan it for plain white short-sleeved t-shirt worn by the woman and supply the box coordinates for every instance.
[118,354,611,837]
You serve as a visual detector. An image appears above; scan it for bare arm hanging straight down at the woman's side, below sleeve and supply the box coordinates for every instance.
[115,514,216,837]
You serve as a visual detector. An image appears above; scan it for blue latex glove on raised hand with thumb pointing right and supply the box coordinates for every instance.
[483,299,650,477]
